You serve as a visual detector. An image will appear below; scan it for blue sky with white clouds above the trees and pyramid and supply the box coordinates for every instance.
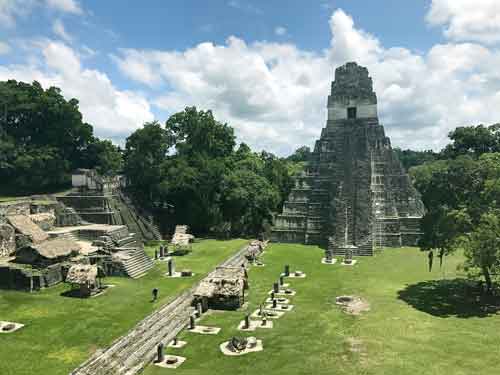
[0,0,500,156]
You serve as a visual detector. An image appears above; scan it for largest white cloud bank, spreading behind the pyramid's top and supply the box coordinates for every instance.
[114,10,500,154]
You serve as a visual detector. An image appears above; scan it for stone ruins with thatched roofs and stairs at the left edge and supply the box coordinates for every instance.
[0,174,160,293]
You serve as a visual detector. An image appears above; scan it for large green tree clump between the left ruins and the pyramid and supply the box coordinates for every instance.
[125,107,292,238]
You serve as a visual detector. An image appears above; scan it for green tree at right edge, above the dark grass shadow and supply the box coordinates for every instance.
[411,125,500,288]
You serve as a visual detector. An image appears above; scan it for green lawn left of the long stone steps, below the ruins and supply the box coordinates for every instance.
[0,240,246,375]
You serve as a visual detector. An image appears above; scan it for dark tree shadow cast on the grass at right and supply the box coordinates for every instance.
[398,279,500,318]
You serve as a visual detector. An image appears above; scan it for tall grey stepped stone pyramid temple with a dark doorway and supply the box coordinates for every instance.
[272,62,424,255]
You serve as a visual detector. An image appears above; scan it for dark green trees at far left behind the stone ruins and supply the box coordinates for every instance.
[0,80,121,194]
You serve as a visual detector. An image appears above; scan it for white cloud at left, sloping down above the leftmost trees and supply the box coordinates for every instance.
[0,40,154,141]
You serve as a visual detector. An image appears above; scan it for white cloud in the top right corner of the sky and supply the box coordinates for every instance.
[426,0,500,44]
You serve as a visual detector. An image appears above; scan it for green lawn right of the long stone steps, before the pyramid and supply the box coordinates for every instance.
[145,244,500,375]
